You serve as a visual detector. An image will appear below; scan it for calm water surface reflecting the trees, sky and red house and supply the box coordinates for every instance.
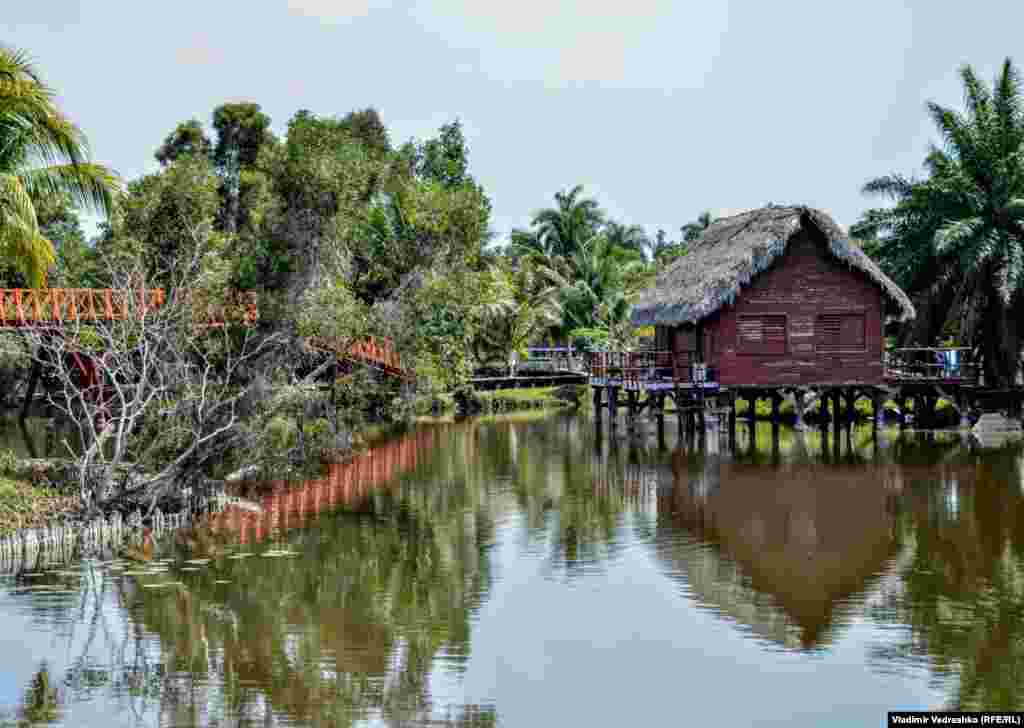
[0,416,1024,728]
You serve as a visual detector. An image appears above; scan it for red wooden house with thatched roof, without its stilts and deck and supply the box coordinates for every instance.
[633,207,914,387]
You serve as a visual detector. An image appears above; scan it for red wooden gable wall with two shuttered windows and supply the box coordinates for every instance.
[702,231,884,386]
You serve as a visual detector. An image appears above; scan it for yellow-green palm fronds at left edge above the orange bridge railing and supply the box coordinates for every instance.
[0,46,121,286]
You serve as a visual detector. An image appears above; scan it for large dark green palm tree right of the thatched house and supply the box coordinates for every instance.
[854,58,1024,385]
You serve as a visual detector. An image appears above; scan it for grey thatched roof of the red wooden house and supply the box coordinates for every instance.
[633,207,914,326]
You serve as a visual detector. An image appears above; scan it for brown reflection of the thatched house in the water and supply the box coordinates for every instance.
[653,444,898,649]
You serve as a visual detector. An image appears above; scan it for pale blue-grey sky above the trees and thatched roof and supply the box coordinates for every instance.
[8,0,1024,238]
